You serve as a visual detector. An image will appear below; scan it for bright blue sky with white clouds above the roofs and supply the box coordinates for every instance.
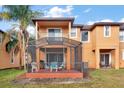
[0,5,124,34]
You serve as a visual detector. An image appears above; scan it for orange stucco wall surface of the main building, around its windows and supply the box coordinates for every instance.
[35,20,124,69]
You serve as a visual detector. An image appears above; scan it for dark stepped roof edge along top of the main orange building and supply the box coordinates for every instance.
[32,17,124,31]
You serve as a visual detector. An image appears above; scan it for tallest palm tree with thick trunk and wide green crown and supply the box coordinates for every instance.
[0,5,43,69]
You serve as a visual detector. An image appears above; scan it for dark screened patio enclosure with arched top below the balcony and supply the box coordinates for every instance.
[27,37,83,70]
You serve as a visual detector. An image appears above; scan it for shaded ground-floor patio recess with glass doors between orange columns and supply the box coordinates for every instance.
[40,48,66,69]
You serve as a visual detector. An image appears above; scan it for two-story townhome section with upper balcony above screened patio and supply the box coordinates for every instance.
[30,17,82,70]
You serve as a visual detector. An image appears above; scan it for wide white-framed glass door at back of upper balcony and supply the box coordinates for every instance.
[48,28,62,37]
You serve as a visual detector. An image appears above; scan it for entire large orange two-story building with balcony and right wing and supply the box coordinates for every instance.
[29,17,124,70]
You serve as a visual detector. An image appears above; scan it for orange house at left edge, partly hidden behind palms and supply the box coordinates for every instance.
[0,30,20,69]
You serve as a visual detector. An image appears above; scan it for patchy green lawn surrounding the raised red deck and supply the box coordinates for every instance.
[0,69,124,88]
